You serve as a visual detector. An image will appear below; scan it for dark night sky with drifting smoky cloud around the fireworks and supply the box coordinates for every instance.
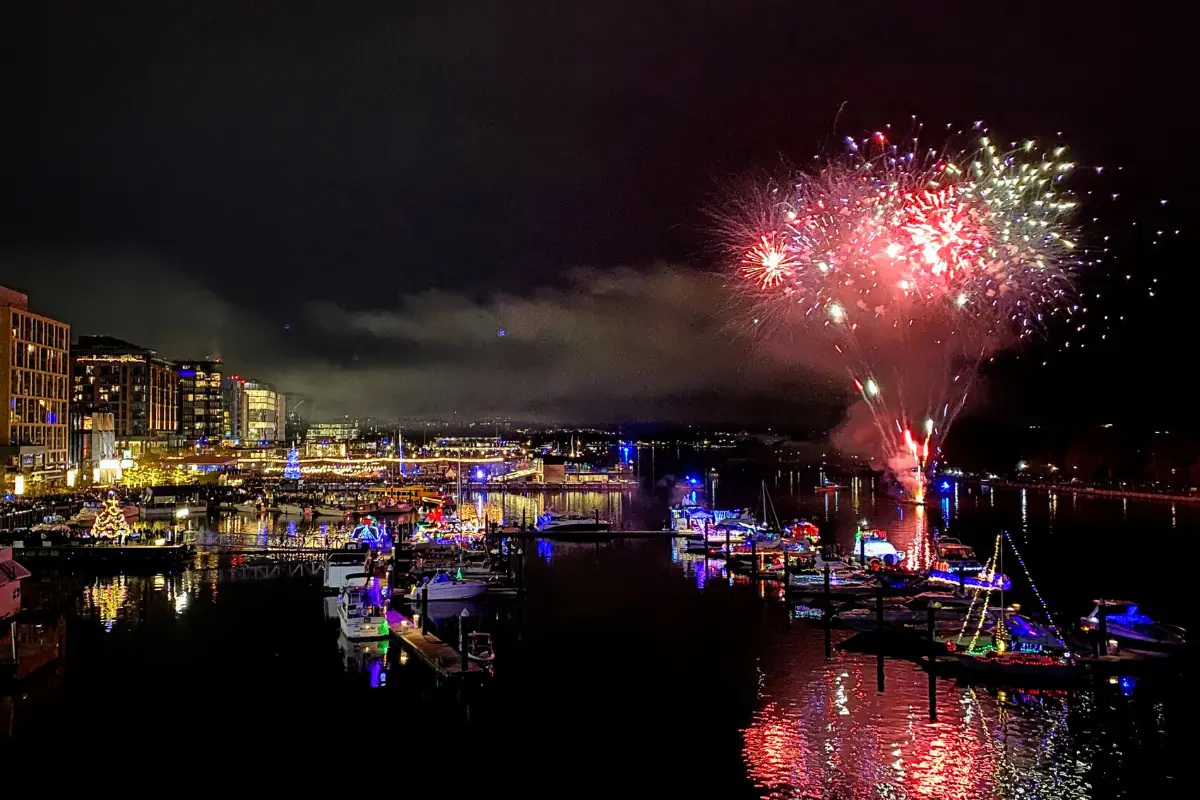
[0,0,1196,431]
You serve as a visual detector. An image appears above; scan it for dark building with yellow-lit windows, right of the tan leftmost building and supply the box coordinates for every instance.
[71,336,179,456]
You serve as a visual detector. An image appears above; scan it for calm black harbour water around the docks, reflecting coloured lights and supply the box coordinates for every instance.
[0,473,1200,800]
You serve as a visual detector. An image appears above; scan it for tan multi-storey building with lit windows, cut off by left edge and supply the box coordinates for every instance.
[0,287,71,492]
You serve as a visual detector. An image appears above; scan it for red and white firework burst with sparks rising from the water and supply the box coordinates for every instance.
[714,122,1087,496]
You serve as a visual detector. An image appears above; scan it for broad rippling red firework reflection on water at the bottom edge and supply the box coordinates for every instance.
[743,647,1092,800]
